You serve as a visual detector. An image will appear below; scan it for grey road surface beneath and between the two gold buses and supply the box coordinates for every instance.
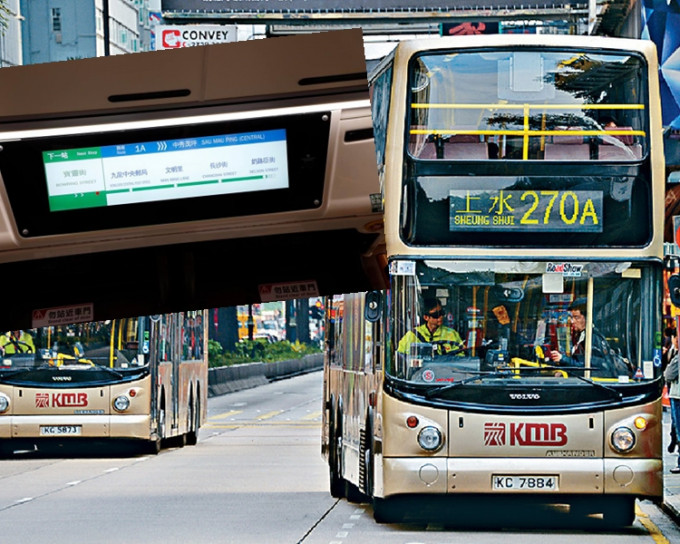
[0,372,680,544]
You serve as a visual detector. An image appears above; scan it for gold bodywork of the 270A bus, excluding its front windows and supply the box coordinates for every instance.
[322,35,664,525]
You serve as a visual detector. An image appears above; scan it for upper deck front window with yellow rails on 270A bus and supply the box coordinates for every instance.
[408,49,649,162]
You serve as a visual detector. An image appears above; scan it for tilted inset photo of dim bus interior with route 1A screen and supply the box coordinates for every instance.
[0,29,386,329]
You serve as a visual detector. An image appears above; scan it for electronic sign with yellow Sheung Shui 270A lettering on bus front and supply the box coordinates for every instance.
[449,189,603,232]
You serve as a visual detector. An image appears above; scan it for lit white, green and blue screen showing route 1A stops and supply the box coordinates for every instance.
[42,129,290,212]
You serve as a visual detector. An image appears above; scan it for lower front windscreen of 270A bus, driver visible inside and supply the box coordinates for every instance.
[388,260,641,384]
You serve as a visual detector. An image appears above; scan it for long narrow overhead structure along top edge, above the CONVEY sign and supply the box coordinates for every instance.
[161,0,587,18]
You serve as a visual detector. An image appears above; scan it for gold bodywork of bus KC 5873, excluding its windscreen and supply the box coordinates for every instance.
[0,311,208,453]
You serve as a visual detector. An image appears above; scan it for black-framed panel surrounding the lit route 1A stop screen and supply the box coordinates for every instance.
[0,110,332,237]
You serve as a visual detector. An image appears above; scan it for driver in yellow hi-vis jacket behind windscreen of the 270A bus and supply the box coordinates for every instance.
[397,297,465,355]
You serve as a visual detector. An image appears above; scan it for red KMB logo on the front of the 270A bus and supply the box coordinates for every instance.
[484,423,567,446]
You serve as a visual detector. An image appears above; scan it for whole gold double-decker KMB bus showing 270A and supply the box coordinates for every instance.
[322,35,664,526]
